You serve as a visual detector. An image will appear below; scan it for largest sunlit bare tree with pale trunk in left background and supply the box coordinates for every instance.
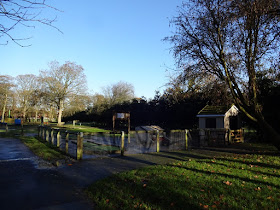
[40,61,87,125]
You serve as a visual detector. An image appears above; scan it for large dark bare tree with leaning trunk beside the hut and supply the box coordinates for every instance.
[166,0,280,149]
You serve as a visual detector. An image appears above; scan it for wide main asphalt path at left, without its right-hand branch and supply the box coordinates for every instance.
[0,138,93,210]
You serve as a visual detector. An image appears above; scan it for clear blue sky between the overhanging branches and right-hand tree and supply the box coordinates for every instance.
[0,0,182,98]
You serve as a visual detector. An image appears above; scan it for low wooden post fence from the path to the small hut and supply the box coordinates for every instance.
[0,126,244,160]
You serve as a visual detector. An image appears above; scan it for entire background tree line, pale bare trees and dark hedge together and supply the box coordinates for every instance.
[0,61,280,135]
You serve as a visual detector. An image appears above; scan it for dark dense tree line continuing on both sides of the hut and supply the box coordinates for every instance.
[64,67,280,135]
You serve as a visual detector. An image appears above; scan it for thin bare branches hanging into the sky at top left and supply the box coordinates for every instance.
[0,0,60,47]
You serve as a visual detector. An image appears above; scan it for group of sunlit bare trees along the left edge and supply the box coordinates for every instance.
[0,61,89,124]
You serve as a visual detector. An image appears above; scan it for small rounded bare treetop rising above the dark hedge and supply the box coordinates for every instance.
[103,81,134,107]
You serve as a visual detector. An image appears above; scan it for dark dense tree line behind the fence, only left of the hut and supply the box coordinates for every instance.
[64,74,232,129]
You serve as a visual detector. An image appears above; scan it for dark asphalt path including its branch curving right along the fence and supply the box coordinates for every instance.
[0,138,188,210]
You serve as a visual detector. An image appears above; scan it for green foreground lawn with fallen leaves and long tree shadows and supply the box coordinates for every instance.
[87,144,280,209]
